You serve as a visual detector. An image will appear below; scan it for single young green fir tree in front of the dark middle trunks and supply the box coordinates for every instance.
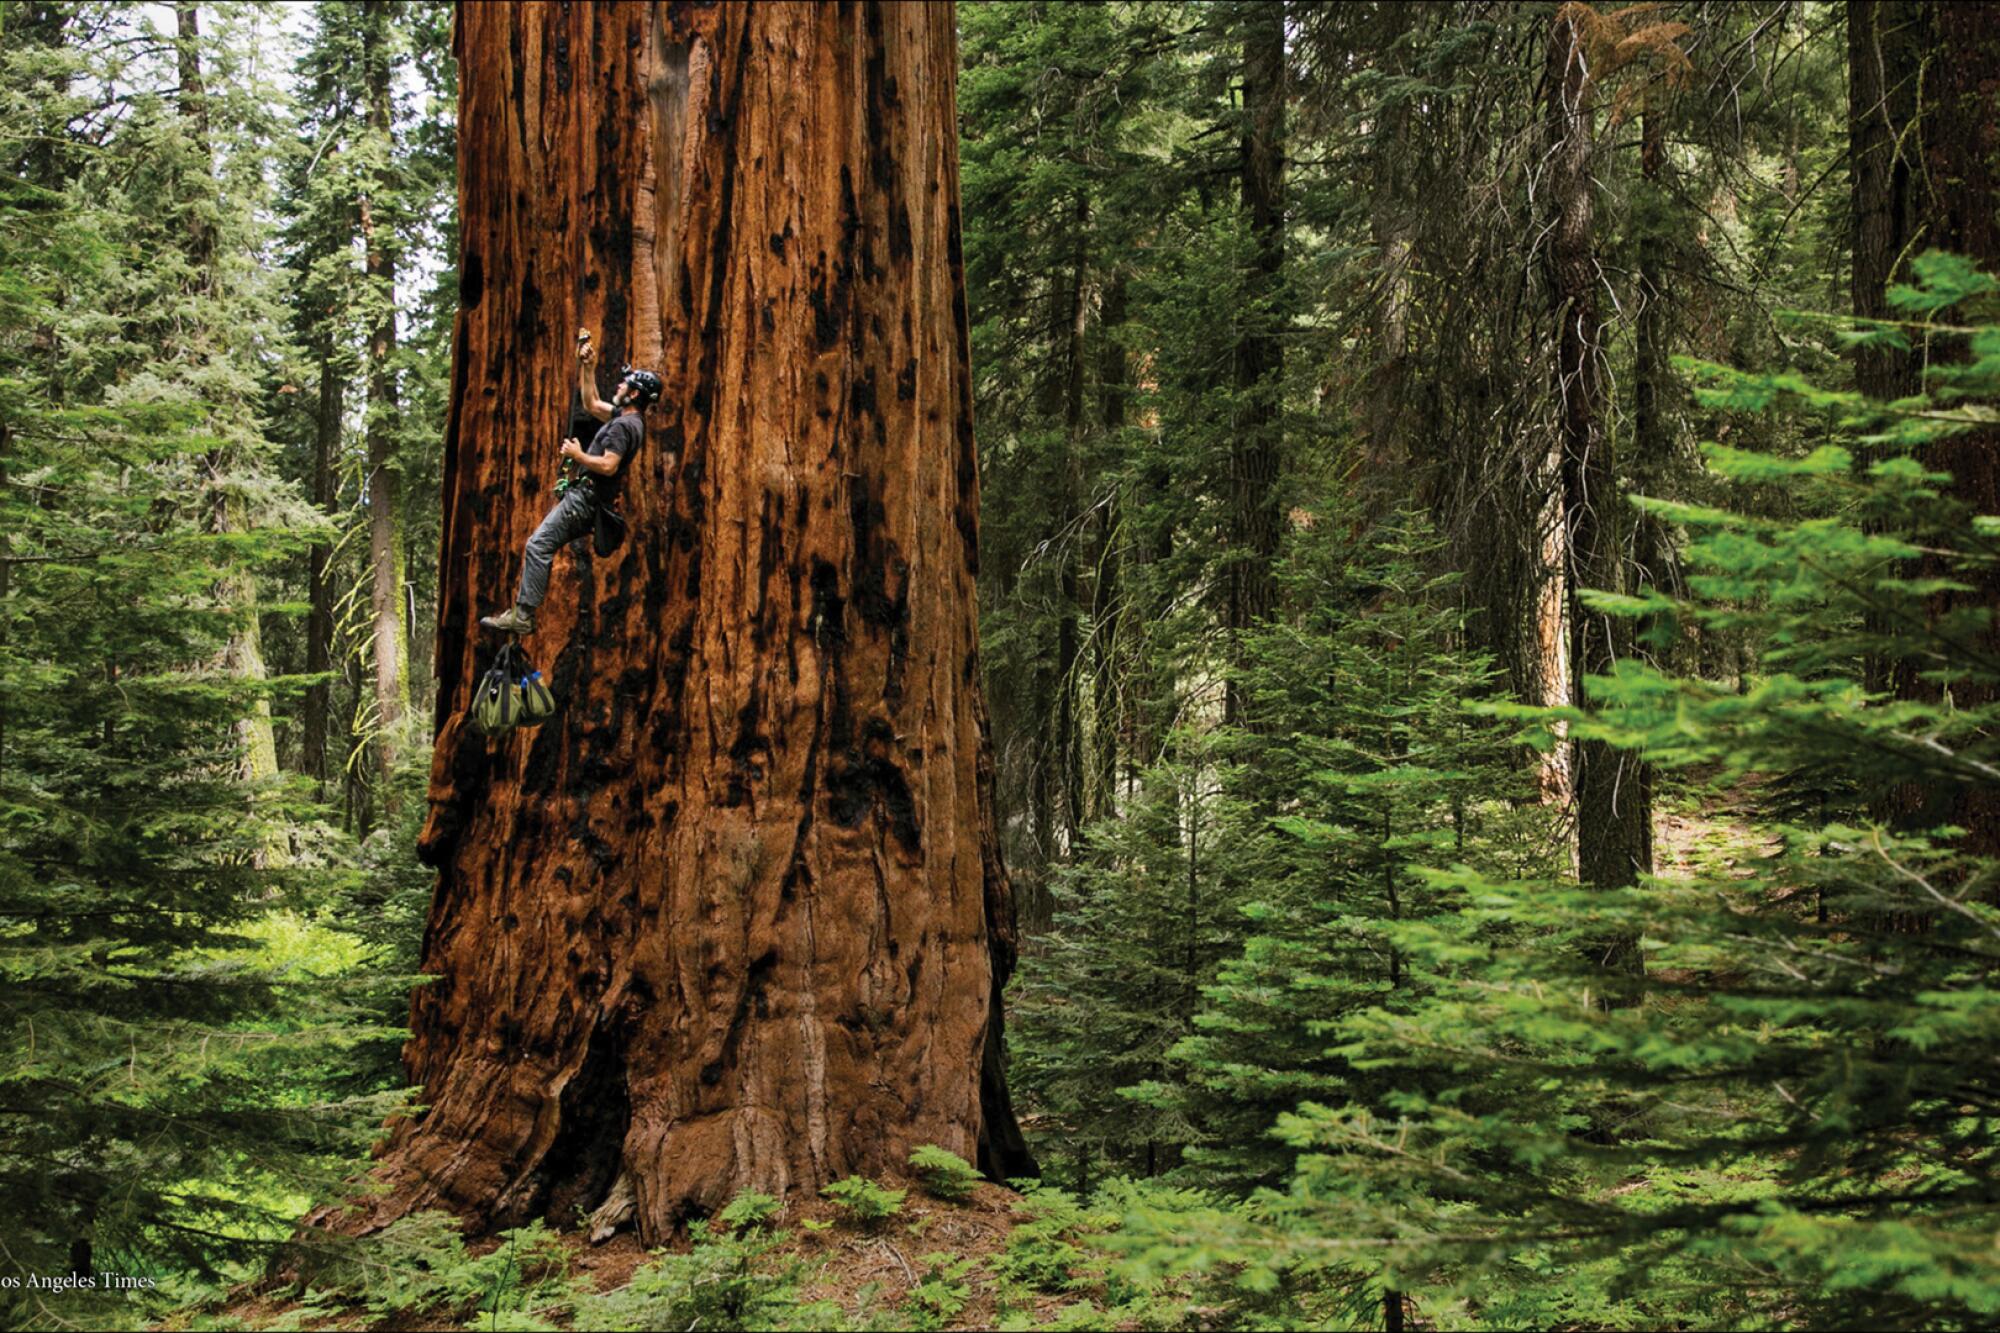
[1142,512,1554,1189]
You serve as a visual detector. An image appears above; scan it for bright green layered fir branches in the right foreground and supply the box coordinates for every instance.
[1112,258,2000,1329]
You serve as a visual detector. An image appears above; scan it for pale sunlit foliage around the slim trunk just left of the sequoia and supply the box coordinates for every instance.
[268,2,456,832]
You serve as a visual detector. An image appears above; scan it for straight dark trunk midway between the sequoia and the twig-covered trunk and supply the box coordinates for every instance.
[1224,2,1286,723]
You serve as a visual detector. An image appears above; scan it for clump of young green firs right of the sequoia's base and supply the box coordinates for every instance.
[1014,500,1556,1189]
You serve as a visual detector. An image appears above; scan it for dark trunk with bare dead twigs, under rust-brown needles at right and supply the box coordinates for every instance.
[1548,7,1652,932]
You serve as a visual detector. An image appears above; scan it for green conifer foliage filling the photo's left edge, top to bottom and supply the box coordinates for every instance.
[0,6,414,1327]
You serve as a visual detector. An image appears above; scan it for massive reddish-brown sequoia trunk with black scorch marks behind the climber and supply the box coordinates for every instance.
[318,4,1032,1243]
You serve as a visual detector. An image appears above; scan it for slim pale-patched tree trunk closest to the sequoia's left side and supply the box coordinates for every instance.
[360,0,410,817]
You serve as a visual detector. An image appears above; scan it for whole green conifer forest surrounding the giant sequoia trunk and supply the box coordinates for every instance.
[0,0,2000,1329]
